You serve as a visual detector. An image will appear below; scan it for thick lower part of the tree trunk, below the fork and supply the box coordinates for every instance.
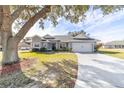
[2,32,19,65]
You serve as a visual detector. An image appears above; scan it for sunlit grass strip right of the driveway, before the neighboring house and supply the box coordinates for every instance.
[99,48,124,59]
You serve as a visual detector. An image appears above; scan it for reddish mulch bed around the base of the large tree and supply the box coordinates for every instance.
[0,58,36,75]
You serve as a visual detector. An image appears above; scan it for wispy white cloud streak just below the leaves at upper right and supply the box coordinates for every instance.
[85,11,124,30]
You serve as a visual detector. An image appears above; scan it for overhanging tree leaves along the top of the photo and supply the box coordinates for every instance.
[11,5,124,29]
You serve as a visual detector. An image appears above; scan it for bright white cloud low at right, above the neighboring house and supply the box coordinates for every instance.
[92,26,124,42]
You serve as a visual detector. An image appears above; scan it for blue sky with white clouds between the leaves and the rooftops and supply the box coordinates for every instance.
[26,10,124,42]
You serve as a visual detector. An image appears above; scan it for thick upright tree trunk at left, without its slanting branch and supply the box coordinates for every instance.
[1,6,19,65]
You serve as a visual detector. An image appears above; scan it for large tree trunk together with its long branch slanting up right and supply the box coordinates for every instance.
[1,6,51,65]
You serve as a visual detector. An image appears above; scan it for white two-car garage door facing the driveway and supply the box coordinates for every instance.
[72,43,93,52]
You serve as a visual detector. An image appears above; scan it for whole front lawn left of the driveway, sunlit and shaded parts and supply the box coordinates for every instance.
[0,52,78,88]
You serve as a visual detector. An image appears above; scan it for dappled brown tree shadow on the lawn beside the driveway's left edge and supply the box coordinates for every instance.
[42,60,78,88]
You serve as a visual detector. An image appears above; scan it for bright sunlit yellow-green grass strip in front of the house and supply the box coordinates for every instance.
[19,52,77,62]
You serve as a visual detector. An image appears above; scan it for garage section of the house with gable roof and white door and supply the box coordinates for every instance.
[71,33,96,53]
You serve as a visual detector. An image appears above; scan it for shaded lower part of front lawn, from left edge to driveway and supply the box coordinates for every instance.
[0,60,77,88]
